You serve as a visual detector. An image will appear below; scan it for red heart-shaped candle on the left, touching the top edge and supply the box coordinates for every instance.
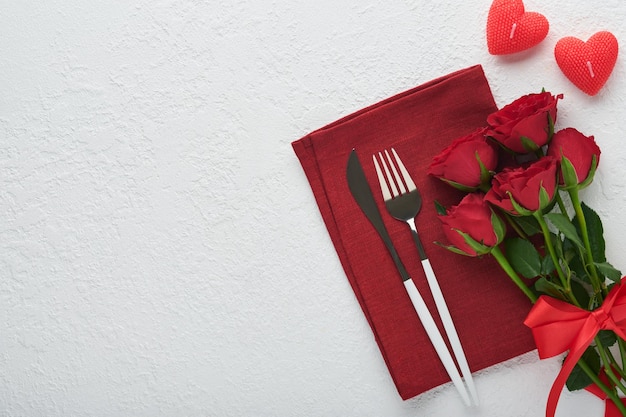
[487,0,550,55]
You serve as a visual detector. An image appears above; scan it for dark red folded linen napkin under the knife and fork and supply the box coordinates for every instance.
[292,66,535,399]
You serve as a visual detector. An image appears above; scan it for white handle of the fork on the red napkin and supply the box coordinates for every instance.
[422,259,478,405]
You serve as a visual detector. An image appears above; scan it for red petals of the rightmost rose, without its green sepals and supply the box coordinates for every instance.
[547,127,600,185]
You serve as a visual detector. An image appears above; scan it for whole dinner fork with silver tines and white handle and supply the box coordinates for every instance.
[372,148,478,405]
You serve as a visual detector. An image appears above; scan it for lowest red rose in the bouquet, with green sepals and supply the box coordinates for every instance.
[439,193,506,256]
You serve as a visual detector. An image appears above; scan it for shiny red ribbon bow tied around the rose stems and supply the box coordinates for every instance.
[524,283,626,417]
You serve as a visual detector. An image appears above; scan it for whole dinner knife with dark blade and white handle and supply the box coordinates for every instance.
[346,149,471,407]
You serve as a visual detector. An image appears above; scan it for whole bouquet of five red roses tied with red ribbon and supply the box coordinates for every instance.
[429,91,626,416]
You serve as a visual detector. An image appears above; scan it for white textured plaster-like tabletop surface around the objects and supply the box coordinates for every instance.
[0,0,626,417]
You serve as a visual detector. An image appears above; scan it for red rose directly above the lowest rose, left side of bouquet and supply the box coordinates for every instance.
[428,128,498,192]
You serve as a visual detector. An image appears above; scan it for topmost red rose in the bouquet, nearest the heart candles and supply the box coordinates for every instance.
[487,92,563,153]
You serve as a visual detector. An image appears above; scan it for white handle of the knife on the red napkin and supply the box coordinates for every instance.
[404,279,471,407]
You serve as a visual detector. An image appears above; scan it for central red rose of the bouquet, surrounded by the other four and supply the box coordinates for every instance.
[485,156,557,215]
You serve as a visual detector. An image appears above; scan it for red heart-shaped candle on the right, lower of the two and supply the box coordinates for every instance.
[554,31,619,96]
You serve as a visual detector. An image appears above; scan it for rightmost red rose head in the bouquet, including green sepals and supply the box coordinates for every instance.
[547,127,600,188]
